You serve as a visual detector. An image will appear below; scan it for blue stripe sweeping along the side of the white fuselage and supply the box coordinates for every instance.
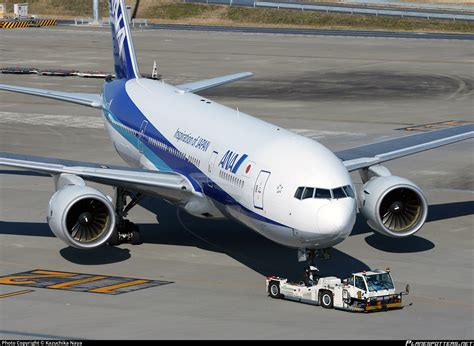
[103,80,288,227]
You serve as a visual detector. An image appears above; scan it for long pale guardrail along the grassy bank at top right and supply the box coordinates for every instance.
[183,0,474,21]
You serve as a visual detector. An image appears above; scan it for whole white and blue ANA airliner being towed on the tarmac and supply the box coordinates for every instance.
[0,0,474,261]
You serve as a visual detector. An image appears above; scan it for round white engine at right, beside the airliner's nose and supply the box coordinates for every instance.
[359,175,428,238]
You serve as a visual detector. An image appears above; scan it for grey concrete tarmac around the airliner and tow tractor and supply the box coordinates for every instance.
[0,27,474,340]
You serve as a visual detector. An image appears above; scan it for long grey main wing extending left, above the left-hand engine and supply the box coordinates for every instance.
[0,152,194,201]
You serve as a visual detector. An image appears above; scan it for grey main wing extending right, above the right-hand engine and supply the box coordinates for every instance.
[335,124,474,172]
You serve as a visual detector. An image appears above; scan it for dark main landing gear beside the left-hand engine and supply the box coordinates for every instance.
[108,187,143,246]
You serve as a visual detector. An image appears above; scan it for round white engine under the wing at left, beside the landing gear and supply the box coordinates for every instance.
[47,184,115,249]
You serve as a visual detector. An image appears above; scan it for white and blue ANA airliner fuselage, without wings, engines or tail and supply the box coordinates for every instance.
[104,79,356,249]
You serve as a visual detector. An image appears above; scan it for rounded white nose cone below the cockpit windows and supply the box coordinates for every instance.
[318,198,356,237]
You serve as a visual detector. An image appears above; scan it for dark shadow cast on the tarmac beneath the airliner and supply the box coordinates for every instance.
[0,198,468,280]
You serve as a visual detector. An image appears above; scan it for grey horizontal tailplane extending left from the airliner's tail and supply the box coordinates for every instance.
[0,84,102,108]
